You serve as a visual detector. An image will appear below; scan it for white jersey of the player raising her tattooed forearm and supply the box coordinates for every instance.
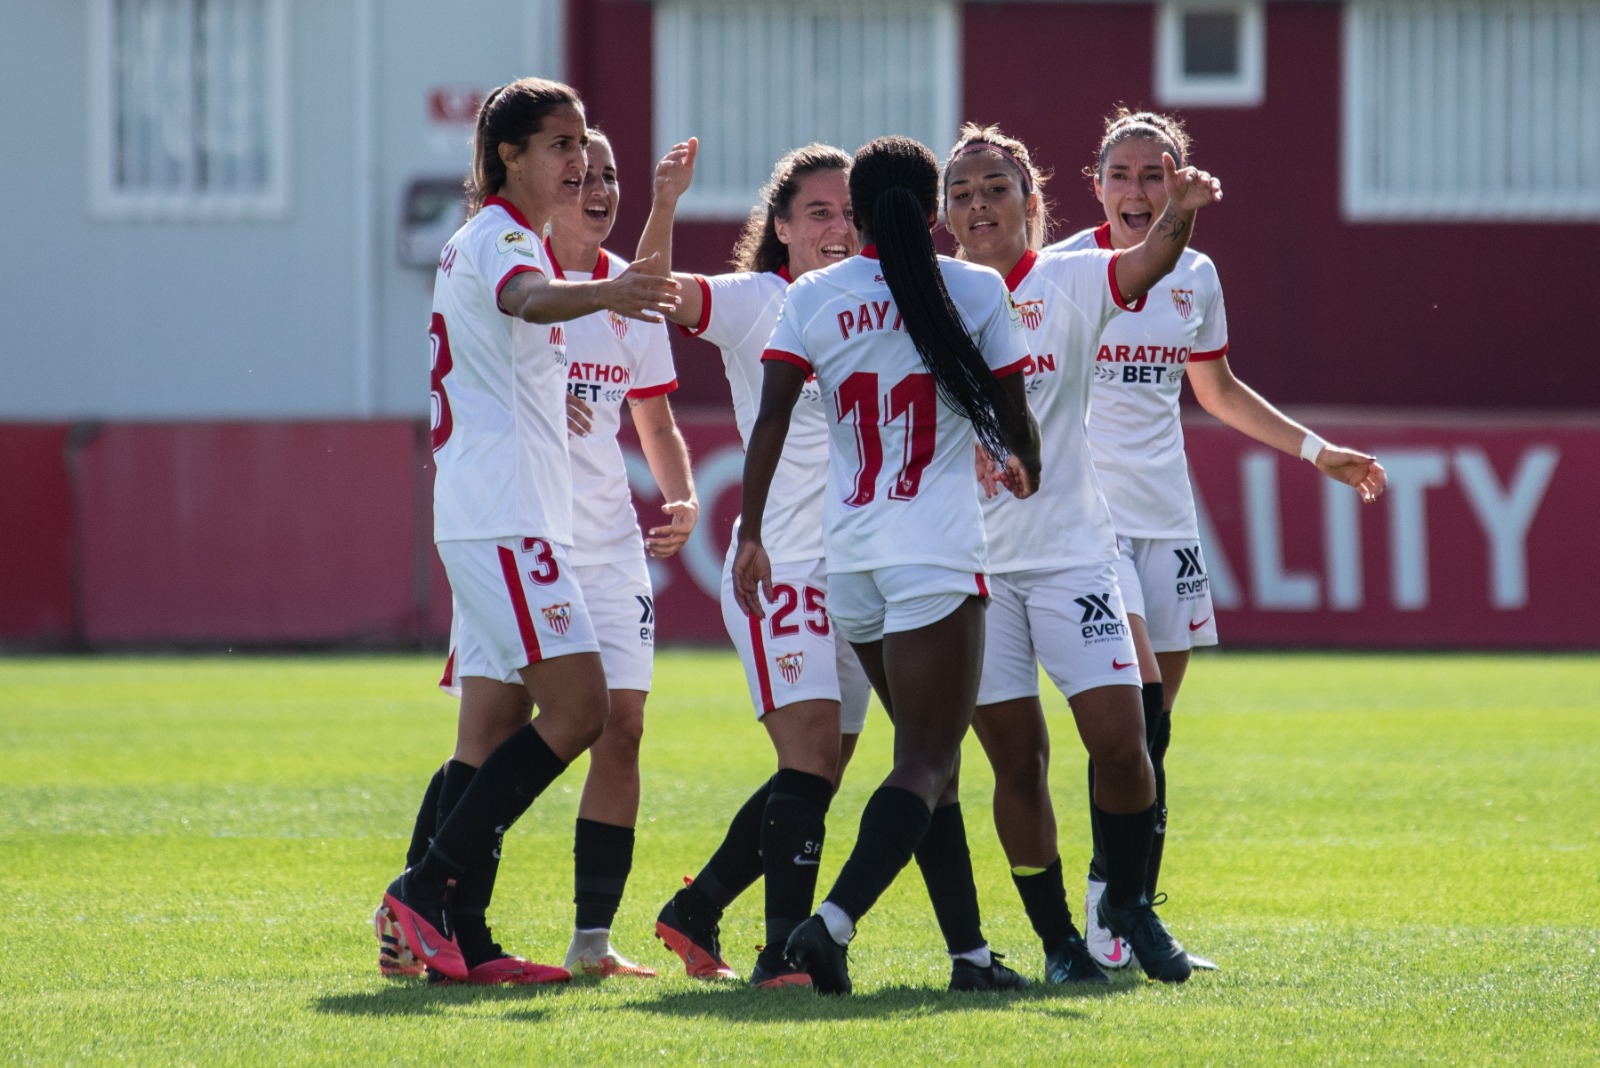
[979,249,1142,574]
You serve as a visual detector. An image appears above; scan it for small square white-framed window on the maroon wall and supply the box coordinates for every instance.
[1155,0,1267,107]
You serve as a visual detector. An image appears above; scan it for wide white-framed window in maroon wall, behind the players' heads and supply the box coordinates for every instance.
[654,0,960,219]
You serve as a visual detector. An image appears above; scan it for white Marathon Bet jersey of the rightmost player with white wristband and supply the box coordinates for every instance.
[1050,222,1227,537]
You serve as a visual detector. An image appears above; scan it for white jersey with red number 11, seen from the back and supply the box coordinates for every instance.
[762,246,1029,574]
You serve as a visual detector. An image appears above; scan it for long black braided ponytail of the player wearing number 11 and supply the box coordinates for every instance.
[850,137,1011,462]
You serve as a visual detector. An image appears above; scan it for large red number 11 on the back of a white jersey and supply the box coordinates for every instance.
[834,371,939,508]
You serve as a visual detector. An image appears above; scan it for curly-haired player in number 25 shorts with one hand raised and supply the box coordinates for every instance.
[638,139,867,986]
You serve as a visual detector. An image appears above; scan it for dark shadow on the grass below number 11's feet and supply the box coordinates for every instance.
[618,983,1133,1023]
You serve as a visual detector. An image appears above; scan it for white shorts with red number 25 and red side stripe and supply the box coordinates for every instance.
[722,549,872,734]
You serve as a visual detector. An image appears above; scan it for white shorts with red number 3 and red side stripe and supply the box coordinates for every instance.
[438,537,600,694]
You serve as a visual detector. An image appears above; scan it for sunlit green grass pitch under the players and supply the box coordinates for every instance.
[0,651,1600,1068]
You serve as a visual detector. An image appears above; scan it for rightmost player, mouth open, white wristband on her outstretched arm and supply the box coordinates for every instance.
[1051,109,1386,967]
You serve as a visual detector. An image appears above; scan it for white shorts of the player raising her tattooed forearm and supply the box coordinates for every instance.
[978,561,1139,705]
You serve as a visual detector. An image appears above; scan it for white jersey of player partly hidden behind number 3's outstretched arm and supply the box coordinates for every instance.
[546,241,678,564]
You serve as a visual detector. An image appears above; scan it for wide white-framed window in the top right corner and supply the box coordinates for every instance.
[1344,0,1600,222]
